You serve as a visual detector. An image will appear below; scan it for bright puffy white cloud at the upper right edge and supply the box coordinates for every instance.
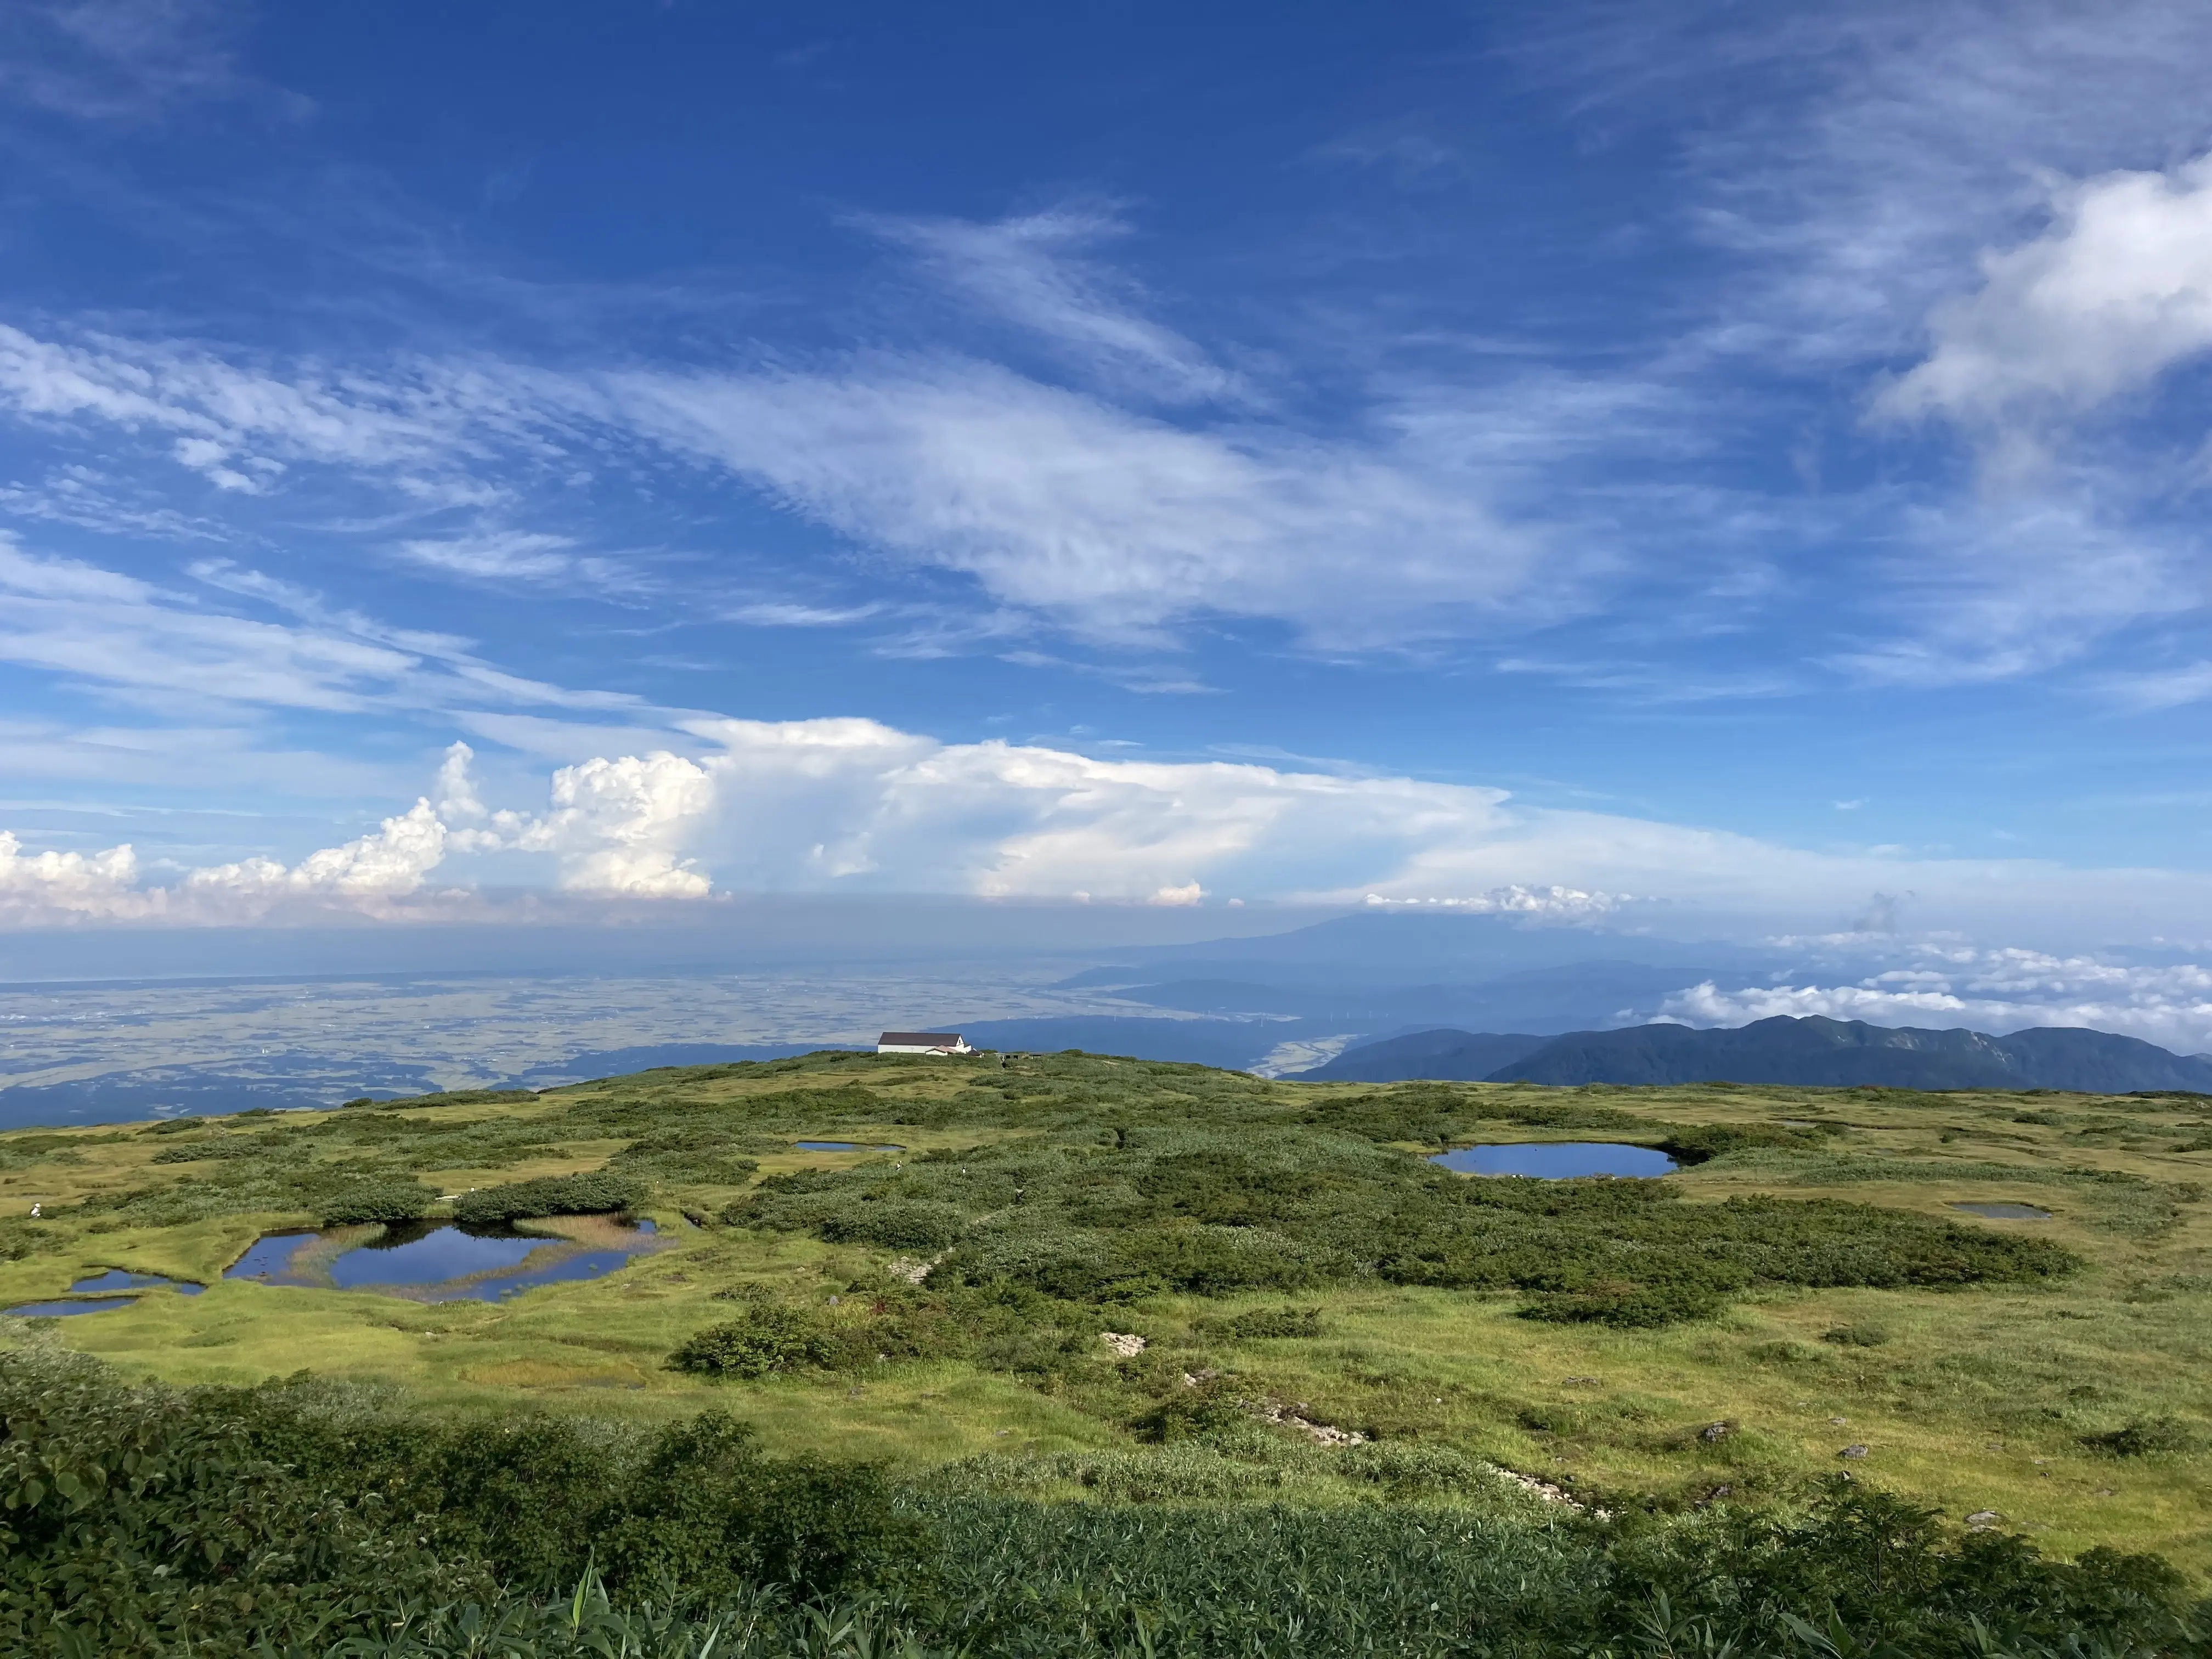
[1876,155,2212,438]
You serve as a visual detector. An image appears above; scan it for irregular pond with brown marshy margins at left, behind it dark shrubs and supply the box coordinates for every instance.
[223,1215,666,1303]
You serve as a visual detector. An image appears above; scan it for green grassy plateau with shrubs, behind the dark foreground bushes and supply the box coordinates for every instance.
[0,1055,2212,1575]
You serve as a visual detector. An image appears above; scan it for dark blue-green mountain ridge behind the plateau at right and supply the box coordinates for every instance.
[1299,1015,2212,1095]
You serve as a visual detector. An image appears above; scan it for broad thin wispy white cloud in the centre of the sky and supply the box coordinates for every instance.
[604,356,1544,646]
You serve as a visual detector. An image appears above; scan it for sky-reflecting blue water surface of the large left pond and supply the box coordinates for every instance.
[223,1221,652,1303]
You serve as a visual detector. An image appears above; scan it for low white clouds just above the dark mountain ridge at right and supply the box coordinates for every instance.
[1661,945,2212,1053]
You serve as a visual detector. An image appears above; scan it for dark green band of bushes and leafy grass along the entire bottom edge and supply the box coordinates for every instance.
[0,1354,2208,1659]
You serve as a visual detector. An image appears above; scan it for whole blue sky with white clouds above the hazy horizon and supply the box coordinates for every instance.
[0,0,2212,1000]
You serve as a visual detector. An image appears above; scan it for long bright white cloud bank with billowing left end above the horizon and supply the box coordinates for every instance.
[11,716,2212,946]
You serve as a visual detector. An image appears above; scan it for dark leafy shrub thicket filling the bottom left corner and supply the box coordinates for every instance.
[0,1354,924,1655]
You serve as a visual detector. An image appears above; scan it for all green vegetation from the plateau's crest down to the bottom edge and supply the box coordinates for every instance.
[0,1055,2212,1655]
